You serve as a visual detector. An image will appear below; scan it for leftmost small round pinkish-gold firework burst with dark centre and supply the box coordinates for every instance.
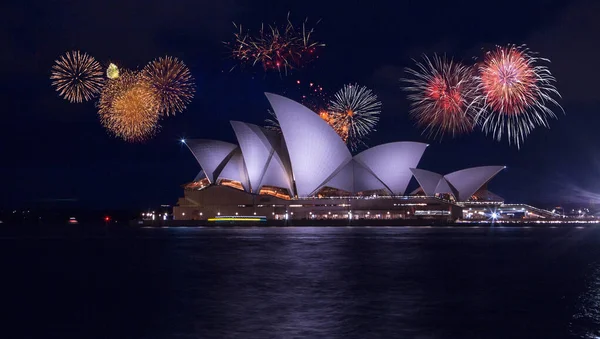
[50,51,104,102]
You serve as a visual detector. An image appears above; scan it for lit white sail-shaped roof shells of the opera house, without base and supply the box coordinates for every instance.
[180,93,505,201]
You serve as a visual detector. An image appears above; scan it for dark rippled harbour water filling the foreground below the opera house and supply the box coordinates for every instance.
[10,227,600,339]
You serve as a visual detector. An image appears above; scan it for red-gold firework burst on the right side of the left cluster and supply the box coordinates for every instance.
[141,56,195,115]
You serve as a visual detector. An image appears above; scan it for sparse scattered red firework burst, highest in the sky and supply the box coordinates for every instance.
[226,14,325,75]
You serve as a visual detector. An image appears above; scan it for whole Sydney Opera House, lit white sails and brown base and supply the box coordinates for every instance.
[173,93,552,220]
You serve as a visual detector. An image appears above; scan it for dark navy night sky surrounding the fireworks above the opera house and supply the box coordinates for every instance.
[0,0,600,208]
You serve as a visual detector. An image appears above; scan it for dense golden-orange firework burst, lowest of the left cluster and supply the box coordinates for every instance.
[98,72,160,142]
